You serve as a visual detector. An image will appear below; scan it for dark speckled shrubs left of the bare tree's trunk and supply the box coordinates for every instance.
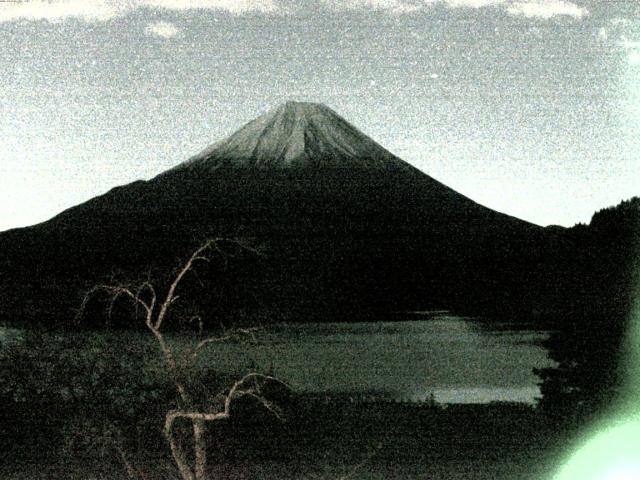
[0,330,175,462]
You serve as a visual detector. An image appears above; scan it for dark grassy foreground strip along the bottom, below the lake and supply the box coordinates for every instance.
[0,397,562,480]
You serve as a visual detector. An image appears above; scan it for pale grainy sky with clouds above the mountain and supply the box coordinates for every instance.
[0,0,640,231]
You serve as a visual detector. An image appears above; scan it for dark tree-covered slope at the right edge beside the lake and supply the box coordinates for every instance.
[538,197,640,425]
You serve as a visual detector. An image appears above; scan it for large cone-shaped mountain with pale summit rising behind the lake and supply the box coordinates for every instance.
[0,102,558,321]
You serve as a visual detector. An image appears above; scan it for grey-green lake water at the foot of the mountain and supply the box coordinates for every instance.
[0,314,553,403]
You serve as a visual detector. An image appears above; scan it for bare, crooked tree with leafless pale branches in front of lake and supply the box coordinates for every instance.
[80,238,284,480]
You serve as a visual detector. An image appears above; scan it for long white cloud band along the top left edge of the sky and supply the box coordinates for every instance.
[0,0,278,23]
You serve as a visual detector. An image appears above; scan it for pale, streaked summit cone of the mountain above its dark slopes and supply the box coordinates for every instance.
[176,101,407,170]
